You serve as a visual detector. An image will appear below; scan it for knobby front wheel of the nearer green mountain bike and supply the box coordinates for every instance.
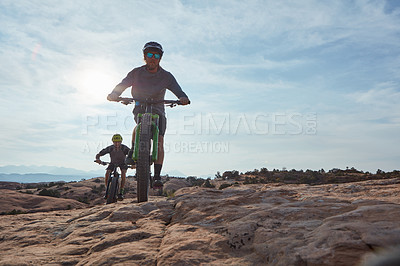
[136,113,152,202]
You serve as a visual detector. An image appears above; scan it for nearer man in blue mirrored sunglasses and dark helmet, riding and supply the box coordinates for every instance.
[107,42,190,186]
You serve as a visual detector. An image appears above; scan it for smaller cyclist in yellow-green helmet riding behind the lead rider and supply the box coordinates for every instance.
[96,134,129,200]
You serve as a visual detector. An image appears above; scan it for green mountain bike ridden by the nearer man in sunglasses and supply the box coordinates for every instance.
[118,97,189,202]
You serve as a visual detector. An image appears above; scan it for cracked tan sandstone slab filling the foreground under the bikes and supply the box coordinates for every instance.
[0,178,400,265]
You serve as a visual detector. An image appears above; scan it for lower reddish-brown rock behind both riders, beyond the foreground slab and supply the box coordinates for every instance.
[0,177,176,214]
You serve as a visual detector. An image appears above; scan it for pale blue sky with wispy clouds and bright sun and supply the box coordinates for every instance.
[0,0,400,177]
